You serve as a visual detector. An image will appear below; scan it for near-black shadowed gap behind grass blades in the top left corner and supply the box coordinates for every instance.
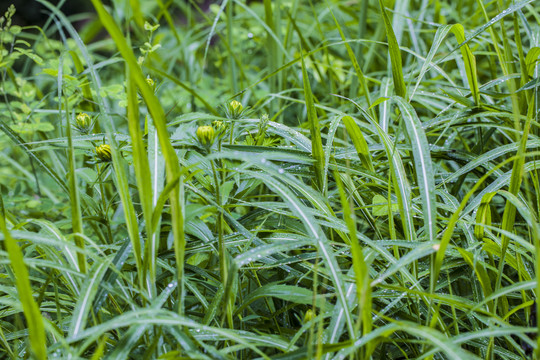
[5,0,94,27]
